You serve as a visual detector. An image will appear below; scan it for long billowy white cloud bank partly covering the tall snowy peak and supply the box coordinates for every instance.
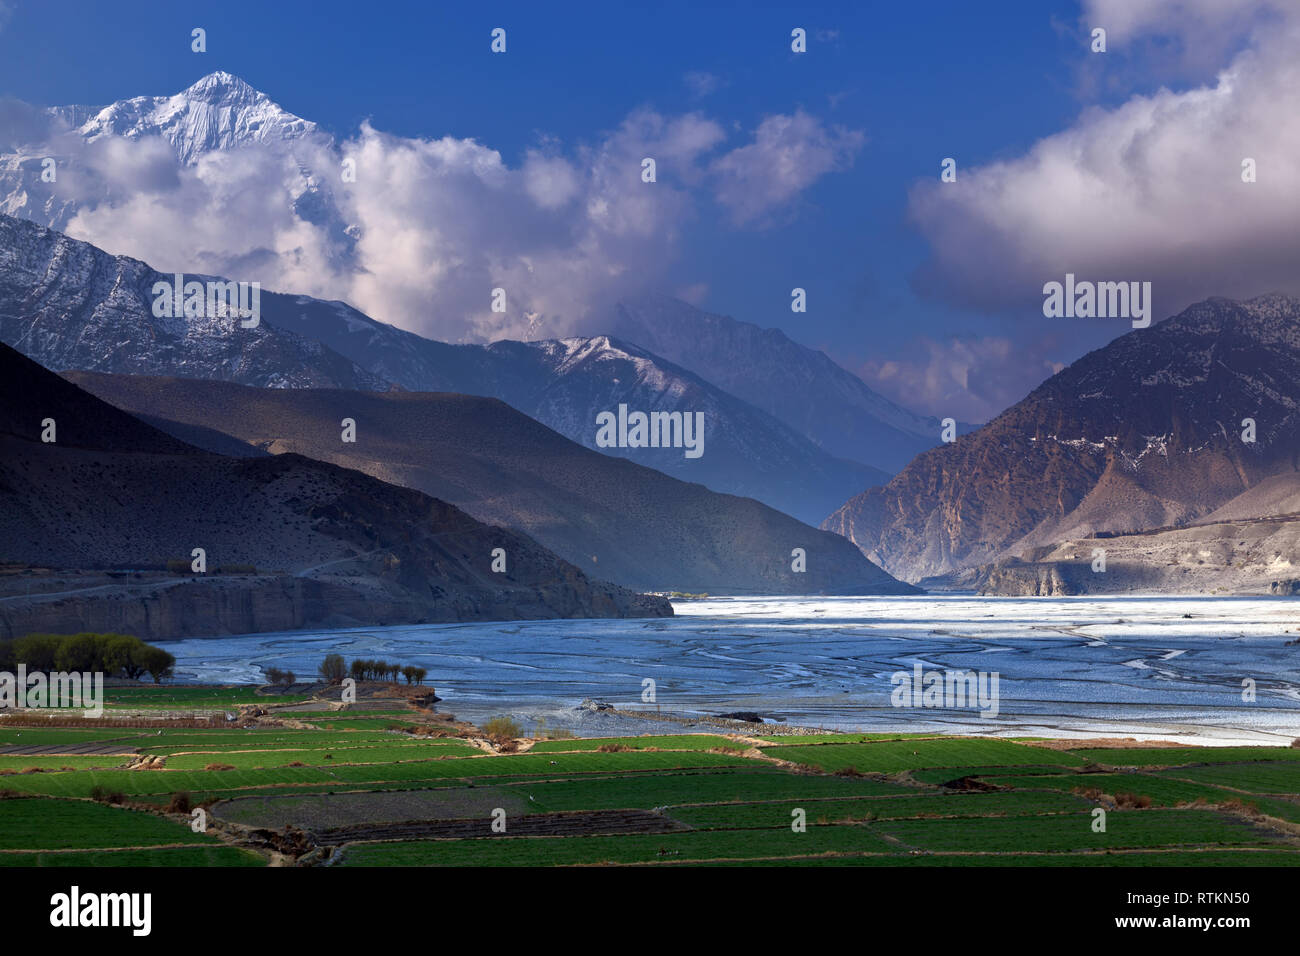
[22,93,861,341]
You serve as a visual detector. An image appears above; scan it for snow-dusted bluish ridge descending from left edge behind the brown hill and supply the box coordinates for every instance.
[0,216,889,525]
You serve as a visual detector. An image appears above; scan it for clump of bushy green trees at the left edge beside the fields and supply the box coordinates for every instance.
[0,631,176,684]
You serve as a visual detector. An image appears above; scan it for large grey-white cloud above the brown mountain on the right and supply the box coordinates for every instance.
[910,0,1300,317]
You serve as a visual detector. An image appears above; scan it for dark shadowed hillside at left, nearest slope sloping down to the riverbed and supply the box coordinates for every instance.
[0,345,672,639]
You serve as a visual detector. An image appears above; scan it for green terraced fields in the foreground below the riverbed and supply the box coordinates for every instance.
[0,691,1300,866]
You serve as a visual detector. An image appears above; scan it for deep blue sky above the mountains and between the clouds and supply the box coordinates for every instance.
[0,0,1300,420]
